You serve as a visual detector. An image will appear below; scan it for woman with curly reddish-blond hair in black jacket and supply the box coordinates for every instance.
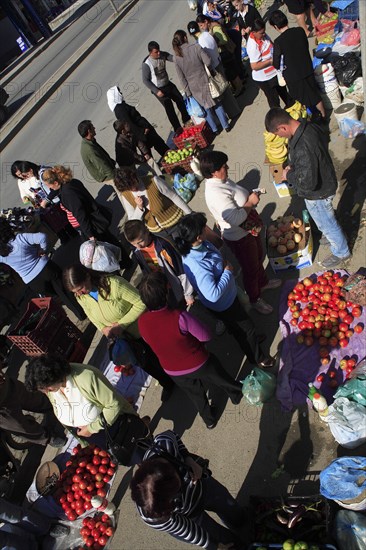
[41,165,132,268]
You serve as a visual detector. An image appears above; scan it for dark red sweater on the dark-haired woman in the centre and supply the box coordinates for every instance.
[138,308,209,375]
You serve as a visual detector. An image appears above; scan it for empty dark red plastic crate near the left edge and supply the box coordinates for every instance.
[7,298,81,357]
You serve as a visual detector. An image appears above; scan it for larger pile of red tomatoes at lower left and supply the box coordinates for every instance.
[54,445,117,521]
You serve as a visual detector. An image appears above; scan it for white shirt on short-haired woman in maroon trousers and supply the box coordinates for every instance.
[205,178,249,241]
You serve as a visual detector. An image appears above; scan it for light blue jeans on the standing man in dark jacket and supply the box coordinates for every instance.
[305,195,350,258]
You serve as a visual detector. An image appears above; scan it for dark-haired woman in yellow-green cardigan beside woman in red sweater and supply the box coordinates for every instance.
[63,264,174,401]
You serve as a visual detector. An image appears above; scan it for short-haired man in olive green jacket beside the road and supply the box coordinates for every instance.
[78,120,116,185]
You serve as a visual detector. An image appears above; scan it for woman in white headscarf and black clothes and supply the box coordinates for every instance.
[107,86,169,156]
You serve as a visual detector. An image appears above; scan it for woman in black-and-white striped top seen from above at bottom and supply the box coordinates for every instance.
[130,430,246,550]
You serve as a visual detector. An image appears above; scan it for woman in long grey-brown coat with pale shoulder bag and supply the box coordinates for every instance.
[172,30,231,134]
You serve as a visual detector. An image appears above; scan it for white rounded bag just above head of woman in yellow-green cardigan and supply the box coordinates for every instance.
[79,241,121,273]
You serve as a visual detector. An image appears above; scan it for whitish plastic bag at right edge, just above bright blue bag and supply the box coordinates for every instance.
[326,397,366,449]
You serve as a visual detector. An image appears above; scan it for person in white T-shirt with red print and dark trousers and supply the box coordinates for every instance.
[247,19,294,108]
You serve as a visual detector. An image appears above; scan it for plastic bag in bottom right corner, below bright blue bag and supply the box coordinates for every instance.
[334,510,366,550]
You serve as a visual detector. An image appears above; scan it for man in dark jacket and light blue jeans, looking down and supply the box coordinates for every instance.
[265,107,351,269]
